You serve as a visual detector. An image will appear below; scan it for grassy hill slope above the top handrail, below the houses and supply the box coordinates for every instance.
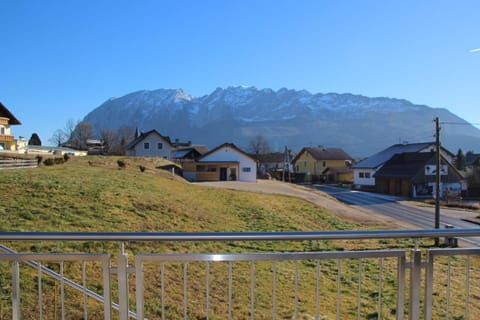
[0,157,359,232]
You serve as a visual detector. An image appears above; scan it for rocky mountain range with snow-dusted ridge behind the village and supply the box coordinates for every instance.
[84,86,480,157]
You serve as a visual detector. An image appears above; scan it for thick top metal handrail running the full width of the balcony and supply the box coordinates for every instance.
[0,228,480,241]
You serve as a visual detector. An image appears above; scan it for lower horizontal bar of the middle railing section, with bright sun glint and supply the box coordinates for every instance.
[135,250,405,262]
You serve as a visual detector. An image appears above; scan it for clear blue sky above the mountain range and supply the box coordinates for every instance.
[0,0,480,144]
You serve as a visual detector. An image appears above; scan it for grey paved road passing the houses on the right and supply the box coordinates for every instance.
[312,185,480,246]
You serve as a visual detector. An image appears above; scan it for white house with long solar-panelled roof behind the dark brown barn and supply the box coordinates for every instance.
[353,142,454,189]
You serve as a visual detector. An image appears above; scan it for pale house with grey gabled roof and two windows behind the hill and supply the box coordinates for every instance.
[125,130,173,160]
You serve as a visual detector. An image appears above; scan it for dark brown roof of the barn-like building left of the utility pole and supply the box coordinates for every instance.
[375,152,435,179]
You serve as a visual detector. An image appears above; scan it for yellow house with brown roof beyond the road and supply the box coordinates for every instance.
[292,147,353,183]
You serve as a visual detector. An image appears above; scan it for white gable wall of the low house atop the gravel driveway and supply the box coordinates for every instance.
[200,147,257,182]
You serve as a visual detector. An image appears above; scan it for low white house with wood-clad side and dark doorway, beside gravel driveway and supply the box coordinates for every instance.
[183,143,257,182]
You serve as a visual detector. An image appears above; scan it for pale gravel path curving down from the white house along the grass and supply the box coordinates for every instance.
[196,180,415,229]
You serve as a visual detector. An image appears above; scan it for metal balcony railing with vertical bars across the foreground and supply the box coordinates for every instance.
[0,229,480,320]
